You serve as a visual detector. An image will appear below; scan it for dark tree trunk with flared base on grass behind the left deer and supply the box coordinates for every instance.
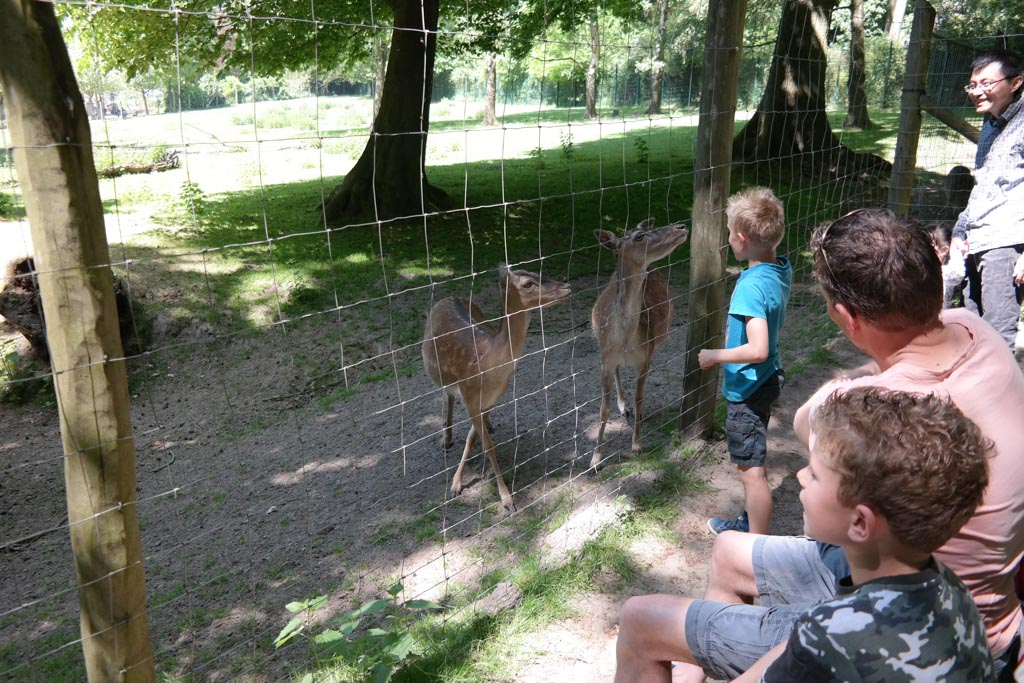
[324,0,446,224]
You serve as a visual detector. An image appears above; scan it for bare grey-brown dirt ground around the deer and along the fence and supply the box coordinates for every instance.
[0,264,859,681]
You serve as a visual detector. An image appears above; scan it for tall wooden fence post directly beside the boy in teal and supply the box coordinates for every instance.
[679,0,746,433]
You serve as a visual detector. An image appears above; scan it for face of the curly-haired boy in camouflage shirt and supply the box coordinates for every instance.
[797,433,854,545]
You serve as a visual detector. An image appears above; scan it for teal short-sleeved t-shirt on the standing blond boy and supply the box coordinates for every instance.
[722,256,793,403]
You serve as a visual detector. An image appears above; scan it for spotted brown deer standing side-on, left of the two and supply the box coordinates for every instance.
[422,263,571,513]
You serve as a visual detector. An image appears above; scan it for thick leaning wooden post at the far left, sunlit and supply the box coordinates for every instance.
[0,0,155,683]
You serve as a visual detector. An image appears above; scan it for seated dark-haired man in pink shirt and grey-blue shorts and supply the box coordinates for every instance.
[616,210,1024,681]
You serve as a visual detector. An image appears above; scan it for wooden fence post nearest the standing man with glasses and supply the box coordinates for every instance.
[889,0,935,216]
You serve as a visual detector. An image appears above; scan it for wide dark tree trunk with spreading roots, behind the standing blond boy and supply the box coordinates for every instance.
[733,0,892,176]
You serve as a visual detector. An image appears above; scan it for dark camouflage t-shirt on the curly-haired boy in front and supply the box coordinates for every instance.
[761,560,995,683]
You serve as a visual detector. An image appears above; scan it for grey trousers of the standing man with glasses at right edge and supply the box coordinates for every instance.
[964,245,1024,351]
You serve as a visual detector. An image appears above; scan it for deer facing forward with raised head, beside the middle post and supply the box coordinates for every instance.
[590,218,689,471]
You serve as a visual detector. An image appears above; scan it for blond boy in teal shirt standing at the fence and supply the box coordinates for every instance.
[697,187,793,535]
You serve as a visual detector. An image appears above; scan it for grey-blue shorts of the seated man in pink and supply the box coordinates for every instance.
[686,536,836,680]
